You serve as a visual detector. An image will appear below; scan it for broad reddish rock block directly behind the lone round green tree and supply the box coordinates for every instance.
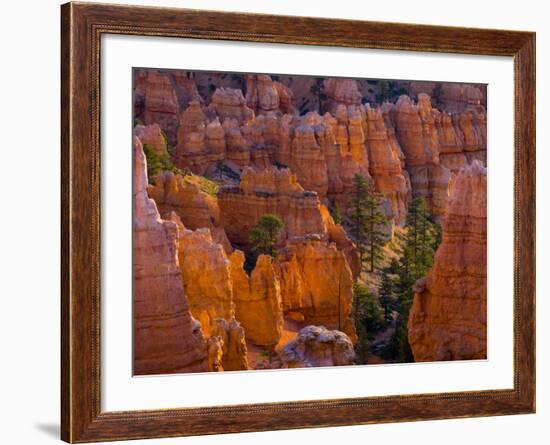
[218,167,328,247]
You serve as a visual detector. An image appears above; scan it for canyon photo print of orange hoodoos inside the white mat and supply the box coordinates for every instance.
[132,68,487,375]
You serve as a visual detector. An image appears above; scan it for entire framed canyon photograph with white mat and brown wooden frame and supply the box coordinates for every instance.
[61,3,535,443]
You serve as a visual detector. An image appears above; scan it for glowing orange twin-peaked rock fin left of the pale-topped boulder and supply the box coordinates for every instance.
[230,250,283,348]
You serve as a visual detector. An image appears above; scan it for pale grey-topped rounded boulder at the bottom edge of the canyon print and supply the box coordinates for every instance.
[281,326,355,368]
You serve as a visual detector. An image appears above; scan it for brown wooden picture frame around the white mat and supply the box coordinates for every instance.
[61,3,535,443]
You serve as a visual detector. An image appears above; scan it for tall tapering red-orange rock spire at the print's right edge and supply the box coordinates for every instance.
[408,161,487,361]
